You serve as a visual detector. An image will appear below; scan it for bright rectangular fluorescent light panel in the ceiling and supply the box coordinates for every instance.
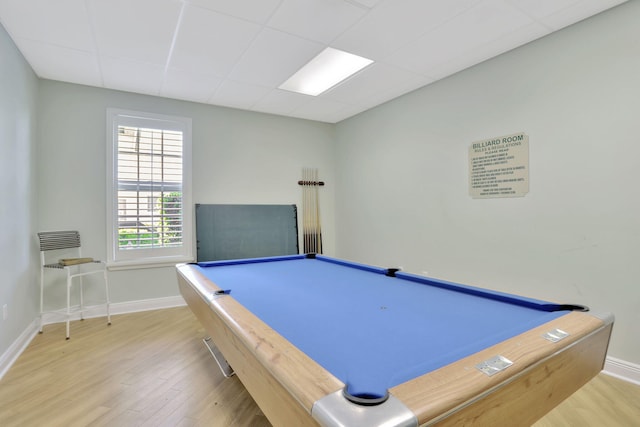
[278,47,373,96]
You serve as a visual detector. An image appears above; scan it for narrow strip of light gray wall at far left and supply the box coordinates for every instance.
[0,25,39,355]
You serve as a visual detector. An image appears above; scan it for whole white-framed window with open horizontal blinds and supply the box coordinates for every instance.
[107,109,193,268]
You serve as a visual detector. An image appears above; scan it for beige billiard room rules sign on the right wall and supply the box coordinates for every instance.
[469,133,529,199]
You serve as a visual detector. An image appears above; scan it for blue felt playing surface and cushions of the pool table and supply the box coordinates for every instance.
[200,256,567,397]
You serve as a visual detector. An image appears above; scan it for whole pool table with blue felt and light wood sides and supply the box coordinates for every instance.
[177,254,613,427]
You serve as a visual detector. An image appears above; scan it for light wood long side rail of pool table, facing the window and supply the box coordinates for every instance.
[178,269,344,427]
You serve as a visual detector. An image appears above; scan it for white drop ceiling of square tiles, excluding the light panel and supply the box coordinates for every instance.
[0,0,624,123]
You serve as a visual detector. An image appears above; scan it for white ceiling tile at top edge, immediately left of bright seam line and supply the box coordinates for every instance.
[87,0,182,65]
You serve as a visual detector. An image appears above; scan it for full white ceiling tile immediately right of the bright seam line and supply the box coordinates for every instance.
[170,7,261,77]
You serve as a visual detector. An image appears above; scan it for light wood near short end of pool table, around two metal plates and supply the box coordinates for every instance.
[390,312,613,426]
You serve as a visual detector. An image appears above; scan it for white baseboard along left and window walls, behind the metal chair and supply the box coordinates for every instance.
[0,296,187,379]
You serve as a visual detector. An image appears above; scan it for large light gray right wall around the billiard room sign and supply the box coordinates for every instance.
[336,1,640,364]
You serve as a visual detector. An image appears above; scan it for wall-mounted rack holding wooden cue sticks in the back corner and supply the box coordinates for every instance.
[298,168,324,254]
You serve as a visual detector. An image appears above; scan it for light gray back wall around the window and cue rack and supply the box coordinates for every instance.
[38,80,335,306]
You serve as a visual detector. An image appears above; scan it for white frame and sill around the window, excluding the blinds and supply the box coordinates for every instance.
[106,108,194,270]
